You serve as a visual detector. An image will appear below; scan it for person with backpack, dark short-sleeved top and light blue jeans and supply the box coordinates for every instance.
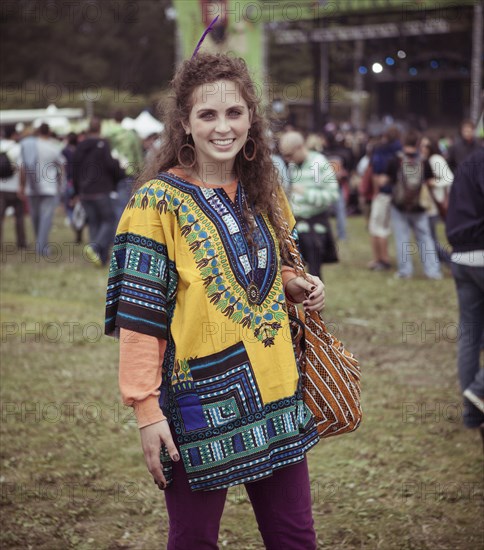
[384,130,442,279]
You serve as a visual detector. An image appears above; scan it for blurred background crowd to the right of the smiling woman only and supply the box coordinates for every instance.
[268,115,482,279]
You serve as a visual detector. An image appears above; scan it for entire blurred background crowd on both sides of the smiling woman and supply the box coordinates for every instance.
[0,115,482,279]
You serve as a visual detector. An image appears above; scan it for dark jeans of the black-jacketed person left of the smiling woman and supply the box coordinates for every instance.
[81,194,117,264]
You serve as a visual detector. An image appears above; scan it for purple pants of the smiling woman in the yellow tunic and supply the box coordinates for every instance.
[165,459,316,550]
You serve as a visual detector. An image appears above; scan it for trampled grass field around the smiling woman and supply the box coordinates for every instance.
[0,209,484,550]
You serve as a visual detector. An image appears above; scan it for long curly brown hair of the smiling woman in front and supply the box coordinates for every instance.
[136,53,292,263]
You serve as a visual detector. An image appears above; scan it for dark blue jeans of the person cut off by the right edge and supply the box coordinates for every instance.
[451,262,484,428]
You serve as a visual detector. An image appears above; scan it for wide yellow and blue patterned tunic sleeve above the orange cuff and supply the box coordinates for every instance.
[105,182,178,339]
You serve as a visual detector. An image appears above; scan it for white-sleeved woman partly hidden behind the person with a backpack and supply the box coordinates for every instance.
[420,136,454,266]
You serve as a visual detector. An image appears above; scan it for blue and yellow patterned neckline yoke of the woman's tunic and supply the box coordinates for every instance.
[129,173,286,346]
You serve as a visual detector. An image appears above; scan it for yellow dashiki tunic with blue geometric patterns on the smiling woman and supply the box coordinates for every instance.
[106,172,318,490]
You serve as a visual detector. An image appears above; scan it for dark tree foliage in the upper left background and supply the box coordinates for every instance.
[0,0,174,101]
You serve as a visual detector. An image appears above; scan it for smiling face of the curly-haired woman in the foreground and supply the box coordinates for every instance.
[183,80,250,177]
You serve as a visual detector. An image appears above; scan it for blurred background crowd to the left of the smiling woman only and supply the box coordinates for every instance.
[0,112,157,266]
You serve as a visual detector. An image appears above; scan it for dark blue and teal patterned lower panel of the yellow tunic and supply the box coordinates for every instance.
[169,342,319,490]
